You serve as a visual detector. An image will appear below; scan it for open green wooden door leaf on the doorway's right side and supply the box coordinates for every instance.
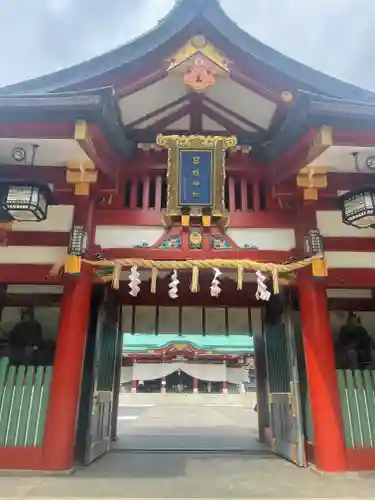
[265,312,306,467]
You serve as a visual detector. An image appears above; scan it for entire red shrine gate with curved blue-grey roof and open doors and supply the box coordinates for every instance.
[0,0,375,472]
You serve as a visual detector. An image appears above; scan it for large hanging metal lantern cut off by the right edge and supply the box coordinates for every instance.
[339,186,375,229]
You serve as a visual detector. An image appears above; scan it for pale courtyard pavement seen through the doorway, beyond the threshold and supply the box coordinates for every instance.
[115,394,267,451]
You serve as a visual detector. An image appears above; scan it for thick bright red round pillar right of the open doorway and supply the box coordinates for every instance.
[299,277,346,472]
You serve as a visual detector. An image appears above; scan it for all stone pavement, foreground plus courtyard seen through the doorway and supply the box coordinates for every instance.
[0,395,375,500]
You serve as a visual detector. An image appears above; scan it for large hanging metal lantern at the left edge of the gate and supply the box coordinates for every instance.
[0,180,51,222]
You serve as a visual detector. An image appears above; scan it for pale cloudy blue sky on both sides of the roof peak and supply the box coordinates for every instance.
[0,0,375,90]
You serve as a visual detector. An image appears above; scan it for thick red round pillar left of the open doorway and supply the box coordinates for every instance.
[43,200,94,470]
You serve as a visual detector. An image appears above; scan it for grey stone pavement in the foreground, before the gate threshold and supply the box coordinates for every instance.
[0,452,375,500]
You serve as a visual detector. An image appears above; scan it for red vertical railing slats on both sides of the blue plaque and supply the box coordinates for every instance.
[123,172,267,213]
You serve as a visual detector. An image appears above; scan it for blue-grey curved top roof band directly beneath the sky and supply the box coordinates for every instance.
[0,0,375,102]
